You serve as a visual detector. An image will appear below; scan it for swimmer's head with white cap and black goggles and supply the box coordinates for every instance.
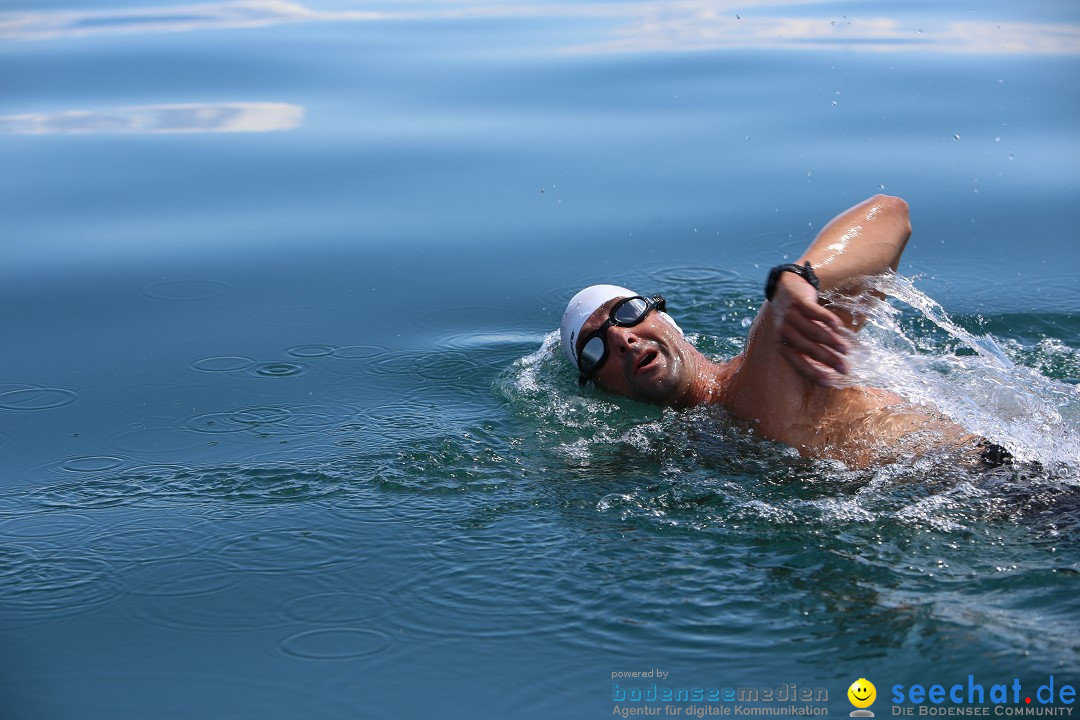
[562,285,699,405]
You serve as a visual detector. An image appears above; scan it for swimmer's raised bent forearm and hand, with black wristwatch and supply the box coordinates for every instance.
[767,195,912,385]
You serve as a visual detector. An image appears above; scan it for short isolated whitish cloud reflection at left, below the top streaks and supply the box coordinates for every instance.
[0,103,303,135]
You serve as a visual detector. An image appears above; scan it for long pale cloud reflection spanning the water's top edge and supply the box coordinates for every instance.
[0,0,1080,54]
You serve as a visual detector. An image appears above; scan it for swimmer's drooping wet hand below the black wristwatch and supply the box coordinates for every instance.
[771,272,851,388]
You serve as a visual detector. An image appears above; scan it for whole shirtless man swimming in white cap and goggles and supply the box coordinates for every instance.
[561,195,1008,467]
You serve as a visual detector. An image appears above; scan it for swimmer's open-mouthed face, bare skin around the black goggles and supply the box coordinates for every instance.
[577,298,690,405]
